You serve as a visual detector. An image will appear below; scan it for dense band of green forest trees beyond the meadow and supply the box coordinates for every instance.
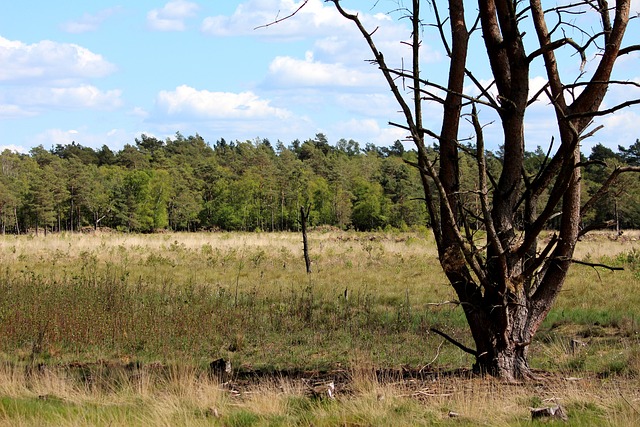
[0,133,640,234]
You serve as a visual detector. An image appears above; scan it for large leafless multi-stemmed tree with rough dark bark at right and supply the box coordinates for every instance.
[282,0,640,380]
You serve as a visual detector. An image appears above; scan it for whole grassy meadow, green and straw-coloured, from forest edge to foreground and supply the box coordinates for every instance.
[0,230,640,426]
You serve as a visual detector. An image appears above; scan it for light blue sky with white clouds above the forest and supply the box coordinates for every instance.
[0,0,640,152]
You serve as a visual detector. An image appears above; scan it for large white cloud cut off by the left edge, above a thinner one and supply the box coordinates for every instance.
[0,37,115,83]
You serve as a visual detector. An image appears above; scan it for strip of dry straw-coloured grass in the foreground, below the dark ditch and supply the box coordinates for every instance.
[0,366,640,426]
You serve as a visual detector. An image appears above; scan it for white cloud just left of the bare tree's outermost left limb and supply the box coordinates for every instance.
[266,52,382,89]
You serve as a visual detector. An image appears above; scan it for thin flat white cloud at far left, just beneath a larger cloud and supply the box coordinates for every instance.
[9,85,122,110]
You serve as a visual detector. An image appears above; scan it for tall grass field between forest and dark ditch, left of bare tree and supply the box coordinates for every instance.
[0,233,470,368]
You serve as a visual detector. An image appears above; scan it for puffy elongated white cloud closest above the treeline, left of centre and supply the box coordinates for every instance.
[156,85,291,120]
